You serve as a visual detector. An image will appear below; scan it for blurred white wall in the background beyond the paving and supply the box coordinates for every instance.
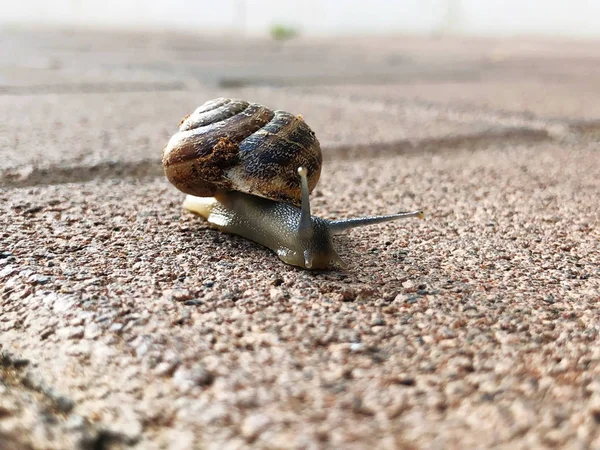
[0,0,600,37]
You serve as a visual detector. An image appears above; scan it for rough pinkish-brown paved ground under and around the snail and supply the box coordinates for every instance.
[0,29,600,449]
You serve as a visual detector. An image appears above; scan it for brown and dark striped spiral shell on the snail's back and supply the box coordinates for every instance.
[162,98,322,205]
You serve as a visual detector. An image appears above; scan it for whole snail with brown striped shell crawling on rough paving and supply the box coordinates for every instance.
[162,98,423,269]
